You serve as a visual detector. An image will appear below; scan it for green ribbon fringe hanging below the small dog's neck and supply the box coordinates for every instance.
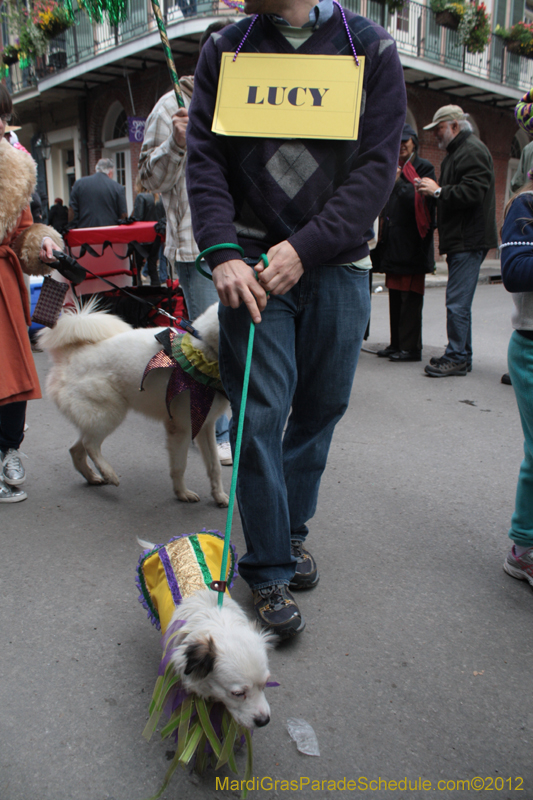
[143,664,253,800]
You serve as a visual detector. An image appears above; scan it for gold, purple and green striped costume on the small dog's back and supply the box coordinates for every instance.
[137,531,237,633]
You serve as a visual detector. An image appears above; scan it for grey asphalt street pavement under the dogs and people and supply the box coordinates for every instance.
[0,284,533,800]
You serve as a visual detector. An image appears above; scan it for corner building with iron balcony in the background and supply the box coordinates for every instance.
[2,0,533,255]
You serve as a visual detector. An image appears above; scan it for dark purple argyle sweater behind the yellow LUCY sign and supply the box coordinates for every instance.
[187,6,406,269]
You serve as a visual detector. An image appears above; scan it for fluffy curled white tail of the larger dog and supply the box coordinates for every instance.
[39,297,132,350]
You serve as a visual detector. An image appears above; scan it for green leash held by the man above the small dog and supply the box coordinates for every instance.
[195,243,268,607]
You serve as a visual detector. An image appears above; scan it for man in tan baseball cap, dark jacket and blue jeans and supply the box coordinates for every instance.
[417,105,498,378]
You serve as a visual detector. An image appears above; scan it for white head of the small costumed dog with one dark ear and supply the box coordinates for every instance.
[167,589,274,728]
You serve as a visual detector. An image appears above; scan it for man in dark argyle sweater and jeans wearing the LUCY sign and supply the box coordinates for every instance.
[187,0,406,638]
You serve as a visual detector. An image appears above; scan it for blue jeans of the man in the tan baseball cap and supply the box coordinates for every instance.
[445,250,487,364]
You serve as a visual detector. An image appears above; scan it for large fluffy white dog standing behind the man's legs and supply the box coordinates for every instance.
[39,302,228,508]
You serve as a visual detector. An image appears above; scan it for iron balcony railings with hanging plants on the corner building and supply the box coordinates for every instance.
[8,0,533,94]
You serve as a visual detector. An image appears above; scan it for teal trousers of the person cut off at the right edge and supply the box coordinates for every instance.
[508,331,533,547]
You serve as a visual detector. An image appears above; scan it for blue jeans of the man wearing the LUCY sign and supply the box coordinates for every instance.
[219,266,370,589]
